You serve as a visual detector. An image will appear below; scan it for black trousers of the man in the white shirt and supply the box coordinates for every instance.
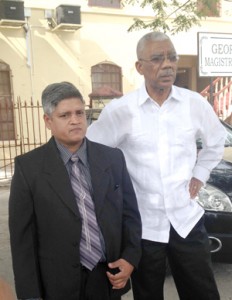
[132,218,220,300]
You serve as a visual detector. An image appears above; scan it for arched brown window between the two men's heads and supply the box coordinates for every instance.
[91,62,122,92]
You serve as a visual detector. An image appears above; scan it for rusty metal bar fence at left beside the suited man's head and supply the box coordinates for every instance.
[0,98,51,179]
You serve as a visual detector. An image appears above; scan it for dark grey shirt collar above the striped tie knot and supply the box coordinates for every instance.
[55,138,88,166]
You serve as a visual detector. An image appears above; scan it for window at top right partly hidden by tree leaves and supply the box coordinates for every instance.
[197,0,221,17]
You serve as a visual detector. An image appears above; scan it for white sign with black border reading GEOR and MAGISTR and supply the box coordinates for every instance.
[198,32,232,77]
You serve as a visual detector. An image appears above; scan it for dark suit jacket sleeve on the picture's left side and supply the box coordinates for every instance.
[9,158,42,299]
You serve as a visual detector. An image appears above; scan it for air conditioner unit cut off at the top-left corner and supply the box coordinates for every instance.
[0,0,25,27]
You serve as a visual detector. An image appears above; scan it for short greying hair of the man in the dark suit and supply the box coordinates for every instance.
[42,81,85,115]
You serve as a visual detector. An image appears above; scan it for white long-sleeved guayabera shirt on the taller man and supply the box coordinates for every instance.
[87,85,225,242]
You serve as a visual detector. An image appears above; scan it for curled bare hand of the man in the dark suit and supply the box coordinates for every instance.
[106,258,134,289]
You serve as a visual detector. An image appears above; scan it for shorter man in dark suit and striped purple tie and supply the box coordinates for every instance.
[9,82,141,300]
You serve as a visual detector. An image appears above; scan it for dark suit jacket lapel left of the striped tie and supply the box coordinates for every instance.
[44,138,80,217]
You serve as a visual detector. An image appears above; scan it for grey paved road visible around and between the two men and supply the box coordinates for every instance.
[0,187,232,300]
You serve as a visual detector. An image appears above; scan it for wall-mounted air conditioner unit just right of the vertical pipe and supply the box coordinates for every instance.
[54,5,81,30]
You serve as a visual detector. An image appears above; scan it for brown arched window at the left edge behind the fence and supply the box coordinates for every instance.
[0,61,15,141]
